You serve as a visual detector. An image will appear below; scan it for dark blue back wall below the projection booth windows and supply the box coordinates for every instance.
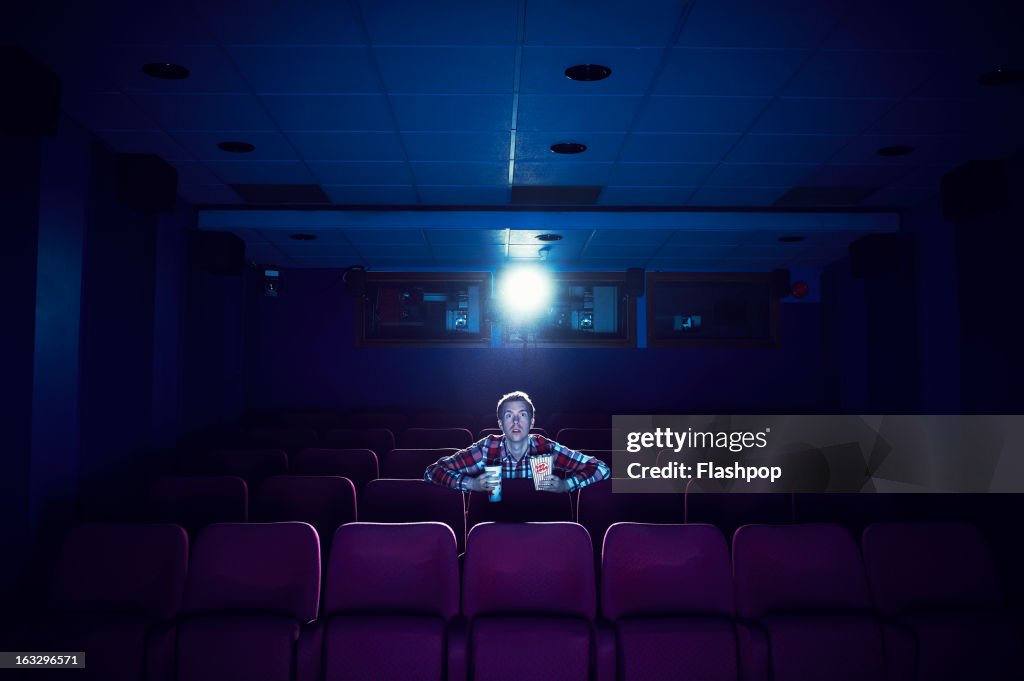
[246,270,823,417]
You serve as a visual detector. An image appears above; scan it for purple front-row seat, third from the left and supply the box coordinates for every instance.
[310,522,459,681]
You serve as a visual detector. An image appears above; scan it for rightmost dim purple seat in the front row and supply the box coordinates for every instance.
[862,522,1024,680]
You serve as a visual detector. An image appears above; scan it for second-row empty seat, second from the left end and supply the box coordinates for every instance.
[253,475,357,558]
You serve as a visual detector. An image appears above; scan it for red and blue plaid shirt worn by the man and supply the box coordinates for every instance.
[423,435,611,492]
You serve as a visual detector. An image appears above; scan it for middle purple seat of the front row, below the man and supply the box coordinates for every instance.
[463,522,598,681]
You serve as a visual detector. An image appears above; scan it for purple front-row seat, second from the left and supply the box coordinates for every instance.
[176,522,321,681]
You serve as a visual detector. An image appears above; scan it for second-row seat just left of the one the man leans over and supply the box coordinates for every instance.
[359,478,466,553]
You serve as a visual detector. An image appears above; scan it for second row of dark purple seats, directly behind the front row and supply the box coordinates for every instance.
[150,473,1015,549]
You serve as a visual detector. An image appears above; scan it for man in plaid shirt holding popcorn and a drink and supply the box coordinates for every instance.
[423,391,611,493]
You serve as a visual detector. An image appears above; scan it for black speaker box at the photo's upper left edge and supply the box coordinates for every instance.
[0,45,60,137]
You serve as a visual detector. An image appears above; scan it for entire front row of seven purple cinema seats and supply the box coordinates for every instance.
[27,522,1021,681]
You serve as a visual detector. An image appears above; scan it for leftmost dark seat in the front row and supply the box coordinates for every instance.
[28,524,188,681]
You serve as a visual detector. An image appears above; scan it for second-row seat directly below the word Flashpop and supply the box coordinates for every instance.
[686,479,793,537]
